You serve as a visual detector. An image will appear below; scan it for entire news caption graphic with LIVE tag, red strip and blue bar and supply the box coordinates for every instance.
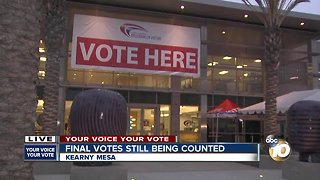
[24,136,260,162]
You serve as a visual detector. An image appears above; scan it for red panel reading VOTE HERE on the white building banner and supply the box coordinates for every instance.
[76,37,199,74]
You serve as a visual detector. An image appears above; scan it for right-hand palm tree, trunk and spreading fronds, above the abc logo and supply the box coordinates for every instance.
[242,0,309,139]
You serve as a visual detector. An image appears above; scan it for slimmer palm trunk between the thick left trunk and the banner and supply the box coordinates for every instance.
[41,0,66,135]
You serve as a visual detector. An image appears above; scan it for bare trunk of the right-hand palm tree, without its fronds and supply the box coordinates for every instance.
[264,27,281,138]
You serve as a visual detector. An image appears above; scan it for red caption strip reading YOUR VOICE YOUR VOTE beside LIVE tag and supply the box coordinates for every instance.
[60,136,177,143]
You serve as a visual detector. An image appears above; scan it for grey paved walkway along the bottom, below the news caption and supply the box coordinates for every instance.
[35,162,283,180]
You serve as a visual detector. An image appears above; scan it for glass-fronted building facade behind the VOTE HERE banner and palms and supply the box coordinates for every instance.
[37,1,319,142]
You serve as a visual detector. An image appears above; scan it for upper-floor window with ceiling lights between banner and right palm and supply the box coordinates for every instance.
[207,56,263,94]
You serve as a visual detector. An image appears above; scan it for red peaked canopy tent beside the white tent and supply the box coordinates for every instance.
[207,99,240,142]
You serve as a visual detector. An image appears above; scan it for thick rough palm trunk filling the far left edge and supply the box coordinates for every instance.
[0,0,41,180]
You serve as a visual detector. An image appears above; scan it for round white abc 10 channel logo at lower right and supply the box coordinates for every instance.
[266,135,291,161]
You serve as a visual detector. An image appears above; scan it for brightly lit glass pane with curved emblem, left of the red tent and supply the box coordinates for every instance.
[180,106,200,142]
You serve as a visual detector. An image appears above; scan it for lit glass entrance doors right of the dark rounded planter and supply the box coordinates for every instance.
[127,106,160,136]
